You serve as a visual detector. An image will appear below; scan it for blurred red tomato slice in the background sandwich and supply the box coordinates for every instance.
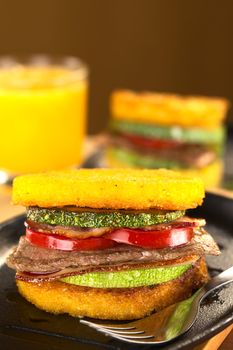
[124,134,180,149]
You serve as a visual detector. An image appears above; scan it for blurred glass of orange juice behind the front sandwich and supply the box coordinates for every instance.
[0,55,88,183]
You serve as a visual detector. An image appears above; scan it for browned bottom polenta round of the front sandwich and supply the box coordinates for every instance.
[16,258,208,320]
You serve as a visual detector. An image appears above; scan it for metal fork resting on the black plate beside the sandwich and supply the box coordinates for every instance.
[80,266,233,344]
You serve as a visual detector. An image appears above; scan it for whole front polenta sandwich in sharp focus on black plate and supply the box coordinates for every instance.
[7,169,219,320]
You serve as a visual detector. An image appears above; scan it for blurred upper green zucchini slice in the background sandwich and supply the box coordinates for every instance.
[110,120,225,144]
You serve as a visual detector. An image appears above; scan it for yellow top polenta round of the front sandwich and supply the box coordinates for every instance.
[13,169,204,210]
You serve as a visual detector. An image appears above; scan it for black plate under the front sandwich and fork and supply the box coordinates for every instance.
[0,194,233,350]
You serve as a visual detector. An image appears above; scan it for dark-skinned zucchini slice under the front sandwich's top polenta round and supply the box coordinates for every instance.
[27,207,185,228]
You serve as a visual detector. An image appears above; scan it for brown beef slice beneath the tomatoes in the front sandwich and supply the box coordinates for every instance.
[7,229,220,273]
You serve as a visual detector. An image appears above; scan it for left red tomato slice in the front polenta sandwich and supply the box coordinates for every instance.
[26,229,116,251]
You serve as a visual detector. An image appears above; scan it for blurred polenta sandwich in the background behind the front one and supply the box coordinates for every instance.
[106,90,228,188]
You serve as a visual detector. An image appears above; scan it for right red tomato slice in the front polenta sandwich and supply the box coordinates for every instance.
[104,223,193,249]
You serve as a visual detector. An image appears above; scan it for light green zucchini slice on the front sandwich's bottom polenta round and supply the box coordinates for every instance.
[61,264,192,288]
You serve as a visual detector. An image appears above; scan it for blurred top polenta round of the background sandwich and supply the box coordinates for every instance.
[110,90,229,128]
